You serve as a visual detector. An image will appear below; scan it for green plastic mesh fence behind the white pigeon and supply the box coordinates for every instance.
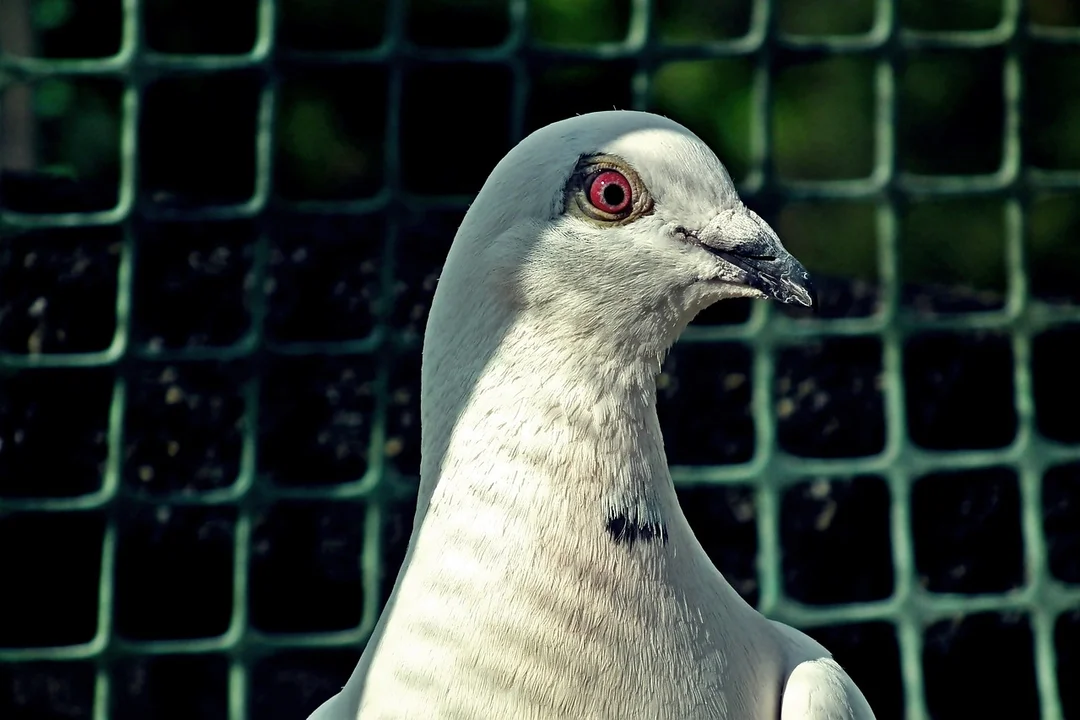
[0,0,1080,720]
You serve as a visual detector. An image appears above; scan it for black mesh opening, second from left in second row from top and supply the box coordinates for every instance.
[138,73,261,208]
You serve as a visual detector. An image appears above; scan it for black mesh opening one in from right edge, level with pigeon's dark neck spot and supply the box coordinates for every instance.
[912,467,1024,595]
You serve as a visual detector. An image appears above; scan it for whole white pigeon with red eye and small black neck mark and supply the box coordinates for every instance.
[311,111,874,720]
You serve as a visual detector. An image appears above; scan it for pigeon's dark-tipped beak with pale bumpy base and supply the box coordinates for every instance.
[693,210,818,308]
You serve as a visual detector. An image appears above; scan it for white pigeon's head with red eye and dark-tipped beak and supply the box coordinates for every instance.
[449,111,813,352]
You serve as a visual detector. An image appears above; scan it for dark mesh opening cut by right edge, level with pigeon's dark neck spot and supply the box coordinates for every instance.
[1042,463,1080,584]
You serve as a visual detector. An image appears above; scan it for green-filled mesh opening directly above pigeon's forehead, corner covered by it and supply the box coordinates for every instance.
[643,58,765,182]
